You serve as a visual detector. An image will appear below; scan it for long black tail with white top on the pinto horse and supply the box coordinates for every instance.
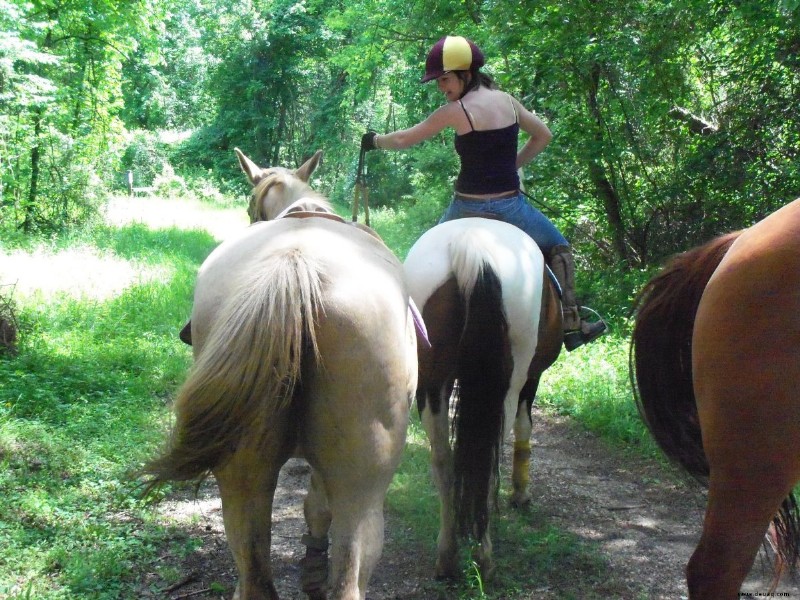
[450,232,511,540]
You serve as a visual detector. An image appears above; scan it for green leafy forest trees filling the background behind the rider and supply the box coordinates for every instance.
[0,0,800,264]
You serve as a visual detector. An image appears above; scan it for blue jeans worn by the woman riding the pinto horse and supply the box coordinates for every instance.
[439,193,569,255]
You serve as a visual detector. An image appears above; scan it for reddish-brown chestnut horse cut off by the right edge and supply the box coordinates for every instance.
[631,200,800,600]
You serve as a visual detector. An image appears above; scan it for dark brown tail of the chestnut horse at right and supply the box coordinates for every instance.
[629,232,741,480]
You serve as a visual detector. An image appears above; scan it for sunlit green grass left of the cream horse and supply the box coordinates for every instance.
[0,219,216,598]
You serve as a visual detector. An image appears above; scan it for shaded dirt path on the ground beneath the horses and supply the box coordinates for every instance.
[142,412,800,600]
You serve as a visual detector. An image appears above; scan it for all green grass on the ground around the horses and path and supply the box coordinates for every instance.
[0,195,664,600]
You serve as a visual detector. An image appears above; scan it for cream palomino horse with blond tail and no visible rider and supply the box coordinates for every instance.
[146,150,417,600]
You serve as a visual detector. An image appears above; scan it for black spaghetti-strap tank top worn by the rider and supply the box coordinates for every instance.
[455,100,519,194]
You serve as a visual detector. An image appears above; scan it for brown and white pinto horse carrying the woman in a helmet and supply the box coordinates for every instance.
[404,218,563,577]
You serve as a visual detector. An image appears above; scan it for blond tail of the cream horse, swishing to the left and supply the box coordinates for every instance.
[144,249,323,493]
